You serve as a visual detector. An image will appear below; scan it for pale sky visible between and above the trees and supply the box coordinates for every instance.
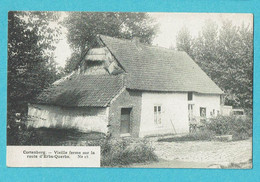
[55,13,253,67]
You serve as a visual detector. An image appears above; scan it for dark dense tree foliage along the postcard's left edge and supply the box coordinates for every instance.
[8,11,62,120]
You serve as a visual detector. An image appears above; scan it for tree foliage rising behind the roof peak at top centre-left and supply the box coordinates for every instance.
[63,12,157,72]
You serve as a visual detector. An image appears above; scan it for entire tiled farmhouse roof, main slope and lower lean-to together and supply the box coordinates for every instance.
[37,35,223,107]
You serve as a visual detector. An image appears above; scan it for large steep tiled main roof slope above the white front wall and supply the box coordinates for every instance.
[100,35,223,94]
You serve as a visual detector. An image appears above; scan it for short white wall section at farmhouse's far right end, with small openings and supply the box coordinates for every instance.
[190,93,220,117]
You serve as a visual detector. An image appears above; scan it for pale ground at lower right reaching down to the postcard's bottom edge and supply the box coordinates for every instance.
[131,139,252,168]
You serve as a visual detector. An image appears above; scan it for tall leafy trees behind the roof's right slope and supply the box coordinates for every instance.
[177,20,253,108]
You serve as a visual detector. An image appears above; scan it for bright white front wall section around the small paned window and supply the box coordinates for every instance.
[139,92,189,137]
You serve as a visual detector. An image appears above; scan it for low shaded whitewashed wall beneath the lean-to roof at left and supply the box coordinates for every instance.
[27,104,109,133]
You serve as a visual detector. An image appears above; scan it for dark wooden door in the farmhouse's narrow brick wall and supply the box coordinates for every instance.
[120,108,132,134]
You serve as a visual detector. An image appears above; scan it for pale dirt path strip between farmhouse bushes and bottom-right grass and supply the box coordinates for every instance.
[154,139,252,164]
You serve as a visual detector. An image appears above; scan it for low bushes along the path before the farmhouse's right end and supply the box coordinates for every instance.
[159,116,253,142]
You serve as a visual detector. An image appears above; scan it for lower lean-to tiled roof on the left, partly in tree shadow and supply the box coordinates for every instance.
[37,74,124,107]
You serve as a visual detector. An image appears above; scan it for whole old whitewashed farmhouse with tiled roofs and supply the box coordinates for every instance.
[27,35,223,137]
